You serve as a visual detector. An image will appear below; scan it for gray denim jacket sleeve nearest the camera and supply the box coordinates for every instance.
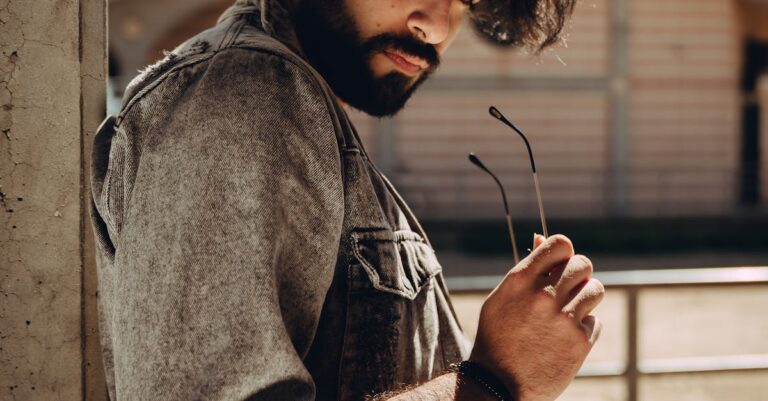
[107,49,344,401]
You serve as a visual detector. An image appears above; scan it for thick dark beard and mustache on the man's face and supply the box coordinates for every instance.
[295,0,440,117]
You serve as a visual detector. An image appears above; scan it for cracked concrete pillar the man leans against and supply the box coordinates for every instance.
[0,0,106,400]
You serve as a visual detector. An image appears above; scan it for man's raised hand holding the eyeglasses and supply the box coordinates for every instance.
[469,235,605,401]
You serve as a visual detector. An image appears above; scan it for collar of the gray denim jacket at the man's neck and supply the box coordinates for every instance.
[219,0,306,59]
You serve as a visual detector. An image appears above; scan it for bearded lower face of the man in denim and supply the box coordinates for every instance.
[296,0,468,116]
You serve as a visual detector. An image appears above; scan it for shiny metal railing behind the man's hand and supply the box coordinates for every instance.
[447,267,768,401]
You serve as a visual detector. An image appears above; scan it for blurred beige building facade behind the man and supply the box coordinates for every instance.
[110,0,768,221]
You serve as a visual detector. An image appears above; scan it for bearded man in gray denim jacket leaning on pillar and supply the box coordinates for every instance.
[91,0,603,401]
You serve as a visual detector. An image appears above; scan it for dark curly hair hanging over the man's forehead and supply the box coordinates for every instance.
[470,0,576,52]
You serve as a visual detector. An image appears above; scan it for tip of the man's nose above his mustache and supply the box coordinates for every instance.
[407,0,451,45]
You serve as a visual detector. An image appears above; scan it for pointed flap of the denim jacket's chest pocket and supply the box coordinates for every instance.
[351,229,442,299]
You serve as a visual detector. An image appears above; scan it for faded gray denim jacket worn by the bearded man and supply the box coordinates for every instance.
[91,0,469,401]
